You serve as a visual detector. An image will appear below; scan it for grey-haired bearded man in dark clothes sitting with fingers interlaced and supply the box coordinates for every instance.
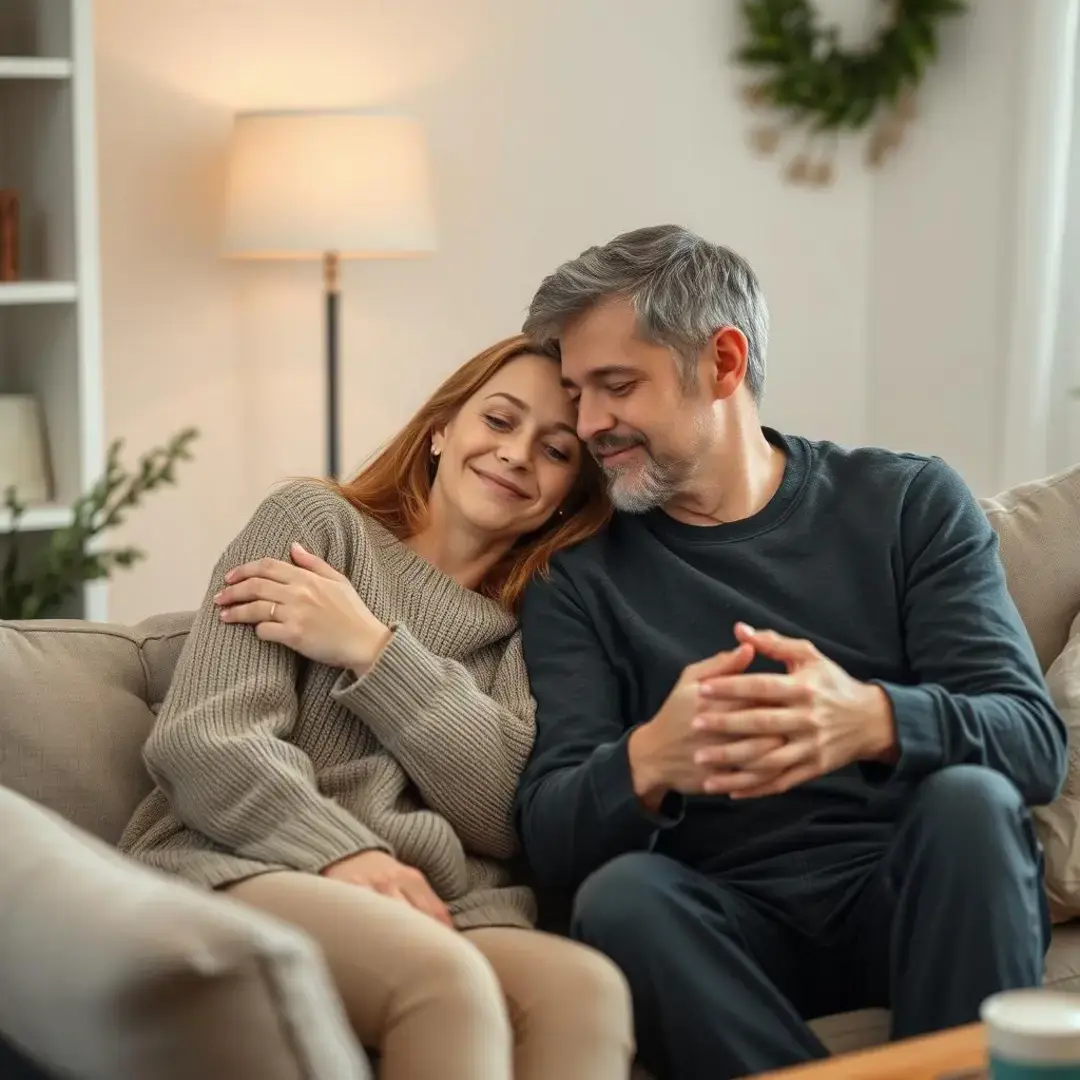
[511,227,1066,1080]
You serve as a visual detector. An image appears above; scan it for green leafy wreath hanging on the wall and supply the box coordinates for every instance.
[735,0,967,186]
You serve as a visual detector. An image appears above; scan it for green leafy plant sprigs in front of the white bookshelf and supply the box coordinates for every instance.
[0,428,198,619]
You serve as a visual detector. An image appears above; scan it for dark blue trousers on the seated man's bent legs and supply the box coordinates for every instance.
[570,766,1050,1080]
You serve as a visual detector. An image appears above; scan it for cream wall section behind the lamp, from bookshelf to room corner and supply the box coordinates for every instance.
[96,0,874,621]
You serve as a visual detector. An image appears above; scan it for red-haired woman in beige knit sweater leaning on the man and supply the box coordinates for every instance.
[120,337,632,1080]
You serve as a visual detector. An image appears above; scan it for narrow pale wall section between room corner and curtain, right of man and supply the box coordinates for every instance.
[866,0,1023,495]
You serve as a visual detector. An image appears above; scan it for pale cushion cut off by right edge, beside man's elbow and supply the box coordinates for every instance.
[1034,615,1080,921]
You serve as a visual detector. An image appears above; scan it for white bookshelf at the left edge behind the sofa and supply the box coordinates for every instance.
[0,0,107,620]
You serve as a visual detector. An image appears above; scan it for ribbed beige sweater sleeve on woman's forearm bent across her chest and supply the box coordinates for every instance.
[335,624,535,859]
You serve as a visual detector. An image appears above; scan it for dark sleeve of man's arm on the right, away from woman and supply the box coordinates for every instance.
[863,459,1066,805]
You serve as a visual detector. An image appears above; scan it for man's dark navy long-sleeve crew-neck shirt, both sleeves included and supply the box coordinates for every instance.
[518,429,1066,889]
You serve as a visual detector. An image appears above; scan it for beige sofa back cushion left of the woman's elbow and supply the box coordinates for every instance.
[0,615,191,843]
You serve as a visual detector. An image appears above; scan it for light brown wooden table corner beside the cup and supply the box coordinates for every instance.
[756,1024,986,1080]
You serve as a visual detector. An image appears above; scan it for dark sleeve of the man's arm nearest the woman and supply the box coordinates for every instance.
[517,567,681,889]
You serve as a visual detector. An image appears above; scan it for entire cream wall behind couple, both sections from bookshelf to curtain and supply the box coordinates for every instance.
[96,0,1050,620]
